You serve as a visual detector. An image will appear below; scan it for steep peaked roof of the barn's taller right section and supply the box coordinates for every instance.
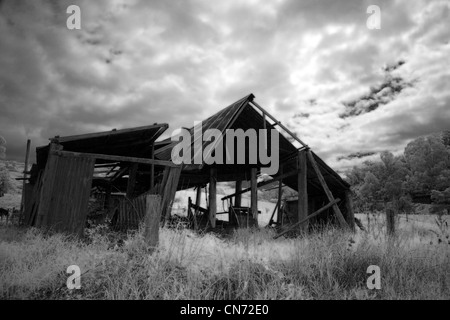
[155,94,350,195]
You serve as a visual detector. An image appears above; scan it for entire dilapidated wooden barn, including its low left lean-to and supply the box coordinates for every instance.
[22,94,354,235]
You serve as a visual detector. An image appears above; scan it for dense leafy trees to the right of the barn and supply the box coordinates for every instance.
[346,131,450,214]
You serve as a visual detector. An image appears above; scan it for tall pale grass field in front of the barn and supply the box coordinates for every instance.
[0,214,450,300]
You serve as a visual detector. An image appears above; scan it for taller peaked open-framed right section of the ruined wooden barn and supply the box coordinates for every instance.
[155,94,354,229]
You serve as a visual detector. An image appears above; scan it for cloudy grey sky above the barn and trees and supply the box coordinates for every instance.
[0,0,450,170]
